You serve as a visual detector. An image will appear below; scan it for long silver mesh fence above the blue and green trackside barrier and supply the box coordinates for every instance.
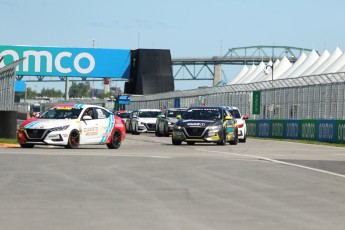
[126,73,345,119]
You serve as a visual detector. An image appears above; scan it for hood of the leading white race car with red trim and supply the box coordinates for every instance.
[20,119,79,129]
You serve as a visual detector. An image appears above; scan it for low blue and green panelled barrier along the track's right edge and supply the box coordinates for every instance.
[246,119,345,144]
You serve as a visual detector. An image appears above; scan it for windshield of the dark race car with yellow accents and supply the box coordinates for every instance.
[182,108,222,120]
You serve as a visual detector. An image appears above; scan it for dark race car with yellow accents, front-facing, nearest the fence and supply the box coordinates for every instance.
[172,106,235,145]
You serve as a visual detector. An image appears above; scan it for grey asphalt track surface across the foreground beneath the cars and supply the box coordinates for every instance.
[0,134,345,230]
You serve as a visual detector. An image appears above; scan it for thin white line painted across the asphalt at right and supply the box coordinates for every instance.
[195,149,345,178]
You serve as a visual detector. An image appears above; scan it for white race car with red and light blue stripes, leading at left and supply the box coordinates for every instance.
[17,104,126,149]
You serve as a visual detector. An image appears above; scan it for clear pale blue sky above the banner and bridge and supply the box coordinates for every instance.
[0,0,345,89]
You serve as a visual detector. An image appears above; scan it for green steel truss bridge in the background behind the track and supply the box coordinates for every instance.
[16,45,312,85]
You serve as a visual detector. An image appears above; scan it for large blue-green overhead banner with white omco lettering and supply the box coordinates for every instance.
[0,46,131,79]
